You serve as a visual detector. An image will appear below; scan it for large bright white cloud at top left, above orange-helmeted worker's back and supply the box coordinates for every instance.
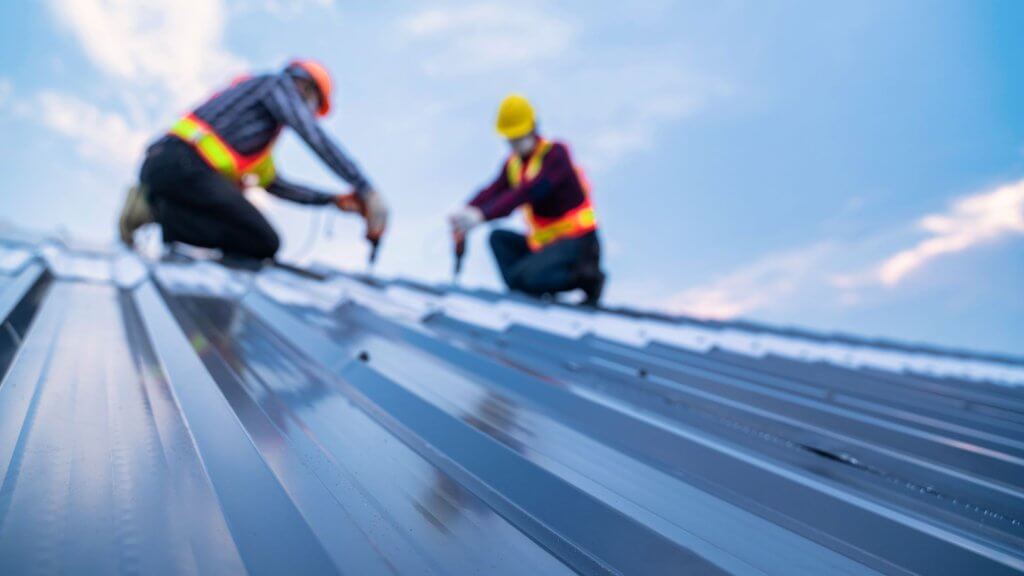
[27,0,244,167]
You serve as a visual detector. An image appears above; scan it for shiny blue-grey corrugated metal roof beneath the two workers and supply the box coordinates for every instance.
[0,238,1024,575]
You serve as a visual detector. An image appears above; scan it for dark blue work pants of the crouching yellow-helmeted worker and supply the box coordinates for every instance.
[490,230,601,296]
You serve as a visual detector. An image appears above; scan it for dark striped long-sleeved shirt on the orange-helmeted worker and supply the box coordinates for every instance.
[195,73,371,204]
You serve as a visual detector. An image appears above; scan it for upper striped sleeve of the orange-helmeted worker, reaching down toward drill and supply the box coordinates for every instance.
[266,74,370,195]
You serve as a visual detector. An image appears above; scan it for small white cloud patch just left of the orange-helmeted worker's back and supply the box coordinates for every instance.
[35,92,151,167]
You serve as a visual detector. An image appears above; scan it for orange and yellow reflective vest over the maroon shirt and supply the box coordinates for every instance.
[505,138,597,252]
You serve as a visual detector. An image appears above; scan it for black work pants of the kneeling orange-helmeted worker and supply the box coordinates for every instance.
[139,136,281,259]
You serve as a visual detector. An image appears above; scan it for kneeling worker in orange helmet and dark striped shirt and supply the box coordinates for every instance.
[120,59,387,260]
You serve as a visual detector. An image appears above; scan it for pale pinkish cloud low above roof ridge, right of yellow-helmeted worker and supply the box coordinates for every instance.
[662,239,835,320]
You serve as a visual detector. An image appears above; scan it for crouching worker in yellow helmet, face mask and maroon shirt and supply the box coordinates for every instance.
[449,94,605,305]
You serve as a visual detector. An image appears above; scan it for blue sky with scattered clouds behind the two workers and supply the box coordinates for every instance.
[0,0,1024,354]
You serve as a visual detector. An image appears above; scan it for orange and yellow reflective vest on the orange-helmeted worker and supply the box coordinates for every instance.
[170,114,278,187]
